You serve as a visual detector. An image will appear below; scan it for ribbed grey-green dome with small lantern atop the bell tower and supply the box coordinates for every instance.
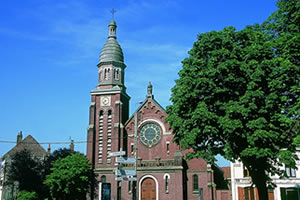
[99,20,124,64]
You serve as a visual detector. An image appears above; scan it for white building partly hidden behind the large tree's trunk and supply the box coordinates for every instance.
[230,149,300,200]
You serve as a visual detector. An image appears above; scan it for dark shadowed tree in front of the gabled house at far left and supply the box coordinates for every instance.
[6,149,43,198]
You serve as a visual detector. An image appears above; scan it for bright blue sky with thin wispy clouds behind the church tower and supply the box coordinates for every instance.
[0,0,276,165]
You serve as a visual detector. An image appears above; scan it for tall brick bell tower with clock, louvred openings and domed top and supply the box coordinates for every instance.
[87,20,130,170]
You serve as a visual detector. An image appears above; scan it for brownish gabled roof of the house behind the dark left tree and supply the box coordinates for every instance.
[1,135,47,160]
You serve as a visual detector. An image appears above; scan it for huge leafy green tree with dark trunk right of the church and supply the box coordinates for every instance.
[167,1,300,200]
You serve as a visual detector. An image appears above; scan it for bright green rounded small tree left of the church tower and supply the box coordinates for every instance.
[44,153,95,200]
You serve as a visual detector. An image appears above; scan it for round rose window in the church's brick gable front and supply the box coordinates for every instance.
[140,123,161,147]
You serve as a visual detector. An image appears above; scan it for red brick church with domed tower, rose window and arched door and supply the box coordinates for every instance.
[87,20,216,200]
